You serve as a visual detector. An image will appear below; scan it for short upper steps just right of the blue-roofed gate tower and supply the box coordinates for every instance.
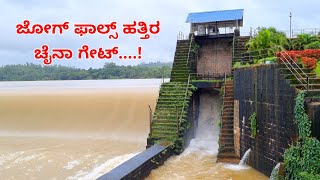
[233,36,250,63]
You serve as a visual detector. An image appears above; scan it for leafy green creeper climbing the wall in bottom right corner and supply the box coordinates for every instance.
[284,92,320,180]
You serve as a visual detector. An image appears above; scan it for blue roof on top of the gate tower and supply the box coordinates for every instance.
[186,9,243,23]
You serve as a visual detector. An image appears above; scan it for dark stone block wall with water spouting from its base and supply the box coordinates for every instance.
[234,64,298,176]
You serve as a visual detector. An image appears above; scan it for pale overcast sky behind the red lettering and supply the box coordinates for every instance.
[0,0,320,68]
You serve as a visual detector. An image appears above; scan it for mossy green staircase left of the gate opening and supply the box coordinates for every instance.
[147,40,195,153]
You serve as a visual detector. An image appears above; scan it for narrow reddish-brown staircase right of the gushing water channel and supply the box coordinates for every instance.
[217,80,239,163]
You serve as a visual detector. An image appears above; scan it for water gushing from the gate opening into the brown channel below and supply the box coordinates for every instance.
[147,92,265,180]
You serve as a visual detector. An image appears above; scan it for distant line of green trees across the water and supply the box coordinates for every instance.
[0,62,172,81]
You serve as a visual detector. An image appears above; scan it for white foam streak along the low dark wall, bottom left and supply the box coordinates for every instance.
[67,153,139,180]
